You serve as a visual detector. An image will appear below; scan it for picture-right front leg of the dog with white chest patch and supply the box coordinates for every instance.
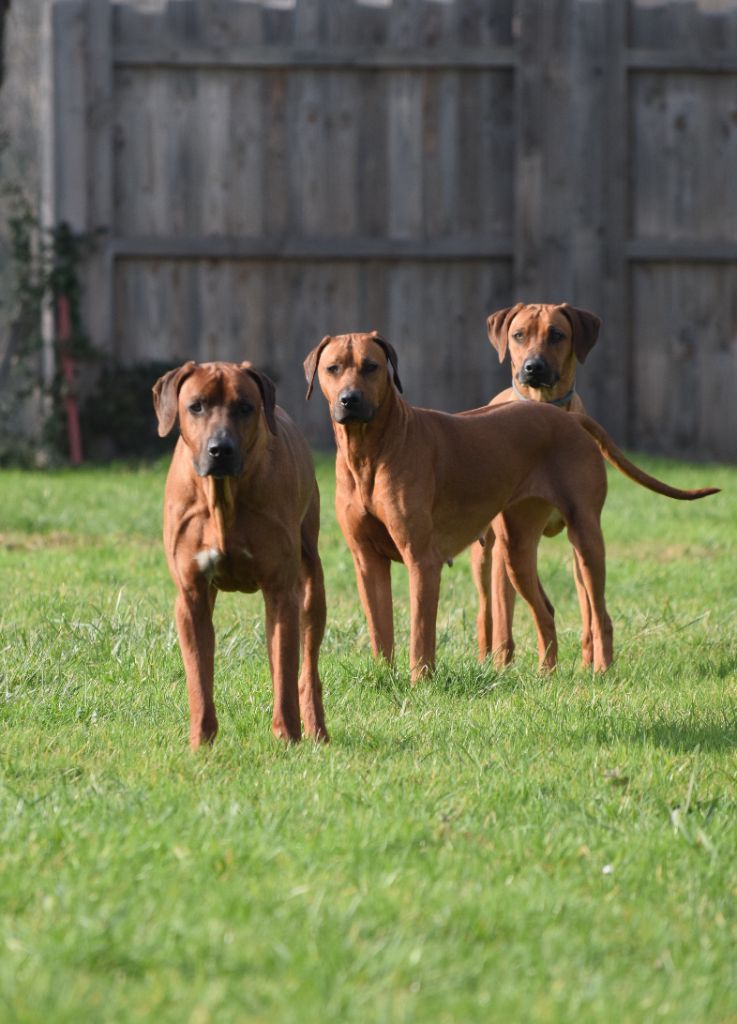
[264,588,302,741]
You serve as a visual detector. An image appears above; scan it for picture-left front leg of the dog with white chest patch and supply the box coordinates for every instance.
[175,584,218,751]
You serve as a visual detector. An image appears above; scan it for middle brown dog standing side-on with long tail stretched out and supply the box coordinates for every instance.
[304,332,716,682]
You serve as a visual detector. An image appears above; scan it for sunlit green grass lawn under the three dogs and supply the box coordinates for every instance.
[0,458,737,1024]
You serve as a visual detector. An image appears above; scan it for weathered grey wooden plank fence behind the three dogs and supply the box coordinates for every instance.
[44,0,737,459]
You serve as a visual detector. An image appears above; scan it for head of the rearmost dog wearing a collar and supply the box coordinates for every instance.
[486,302,601,397]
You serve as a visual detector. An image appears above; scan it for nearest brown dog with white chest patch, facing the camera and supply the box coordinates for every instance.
[154,362,328,748]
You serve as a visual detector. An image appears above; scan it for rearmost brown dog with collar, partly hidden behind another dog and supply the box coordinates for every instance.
[471,302,601,667]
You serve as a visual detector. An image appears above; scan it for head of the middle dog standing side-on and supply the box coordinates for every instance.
[304,331,402,425]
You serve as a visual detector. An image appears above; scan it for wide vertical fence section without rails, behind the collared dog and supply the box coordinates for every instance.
[515,0,631,440]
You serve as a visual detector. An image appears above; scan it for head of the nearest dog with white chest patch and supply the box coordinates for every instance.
[154,361,276,477]
